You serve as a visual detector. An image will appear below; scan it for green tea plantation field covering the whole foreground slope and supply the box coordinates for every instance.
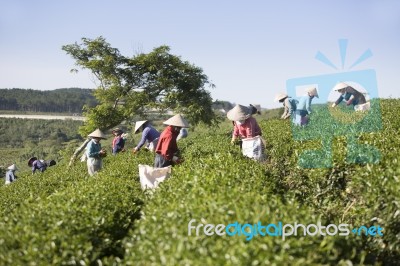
[0,99,400,265]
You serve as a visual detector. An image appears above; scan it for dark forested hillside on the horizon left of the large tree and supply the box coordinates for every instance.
[0,88,97,113]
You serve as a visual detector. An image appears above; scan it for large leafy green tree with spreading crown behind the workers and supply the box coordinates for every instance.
[62,37,217,135]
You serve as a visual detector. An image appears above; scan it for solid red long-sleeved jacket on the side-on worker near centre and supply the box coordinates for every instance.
[155,126,179,161]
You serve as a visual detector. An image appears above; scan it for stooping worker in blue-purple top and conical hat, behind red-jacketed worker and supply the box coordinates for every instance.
[133,120,160,153]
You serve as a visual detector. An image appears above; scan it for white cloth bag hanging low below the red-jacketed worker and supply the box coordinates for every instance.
[139,164,171,190]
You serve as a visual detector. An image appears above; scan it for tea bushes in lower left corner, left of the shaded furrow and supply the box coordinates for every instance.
[0,154,143,265]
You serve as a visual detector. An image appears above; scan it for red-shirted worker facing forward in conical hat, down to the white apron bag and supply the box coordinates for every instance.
[226,104,262,144]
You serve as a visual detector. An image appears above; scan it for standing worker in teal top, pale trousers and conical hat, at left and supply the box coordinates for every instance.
[86,129,107,176]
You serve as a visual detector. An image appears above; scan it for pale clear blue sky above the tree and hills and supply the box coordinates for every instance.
[0,0,400,108]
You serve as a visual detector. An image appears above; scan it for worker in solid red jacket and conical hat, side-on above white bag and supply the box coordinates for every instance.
[154,114,189,168]
